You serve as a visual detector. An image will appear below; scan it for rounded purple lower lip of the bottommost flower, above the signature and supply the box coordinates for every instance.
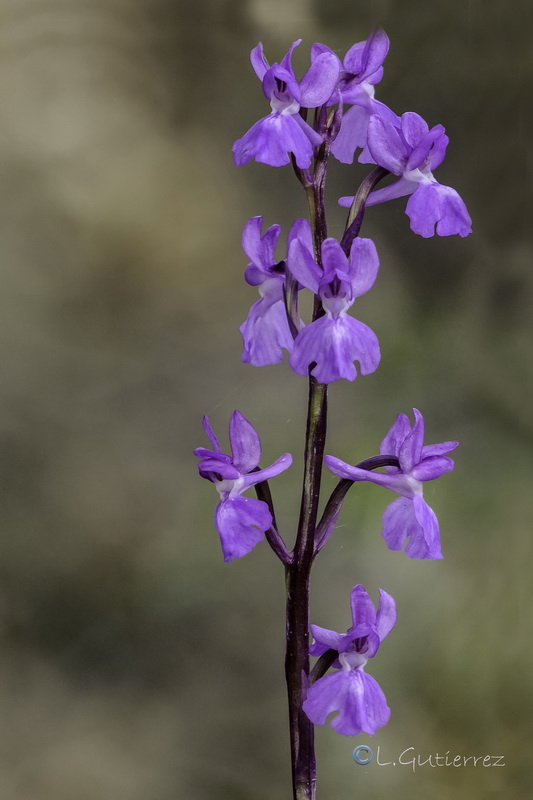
[303,669,390,736]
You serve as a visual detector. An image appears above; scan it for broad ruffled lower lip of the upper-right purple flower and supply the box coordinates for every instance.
[406,181,472,239]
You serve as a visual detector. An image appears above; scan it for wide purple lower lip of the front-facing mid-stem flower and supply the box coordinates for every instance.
[289,314,380,383]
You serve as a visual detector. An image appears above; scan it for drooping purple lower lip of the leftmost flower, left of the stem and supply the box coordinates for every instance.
[215,497,272,561]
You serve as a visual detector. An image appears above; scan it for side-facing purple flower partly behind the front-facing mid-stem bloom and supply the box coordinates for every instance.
[239,217,313,367]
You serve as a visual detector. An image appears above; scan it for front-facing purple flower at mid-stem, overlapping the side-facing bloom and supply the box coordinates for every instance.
[287,233,380,383]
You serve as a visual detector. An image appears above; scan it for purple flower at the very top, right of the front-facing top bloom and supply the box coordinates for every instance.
[311,28,399,164]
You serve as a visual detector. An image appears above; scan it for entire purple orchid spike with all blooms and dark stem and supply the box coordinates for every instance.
[195,30,471,798]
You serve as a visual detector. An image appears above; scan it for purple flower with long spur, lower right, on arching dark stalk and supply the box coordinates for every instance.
[324,408,459,559]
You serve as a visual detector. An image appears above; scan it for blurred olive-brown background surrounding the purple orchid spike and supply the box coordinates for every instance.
[0,0,533,800]
